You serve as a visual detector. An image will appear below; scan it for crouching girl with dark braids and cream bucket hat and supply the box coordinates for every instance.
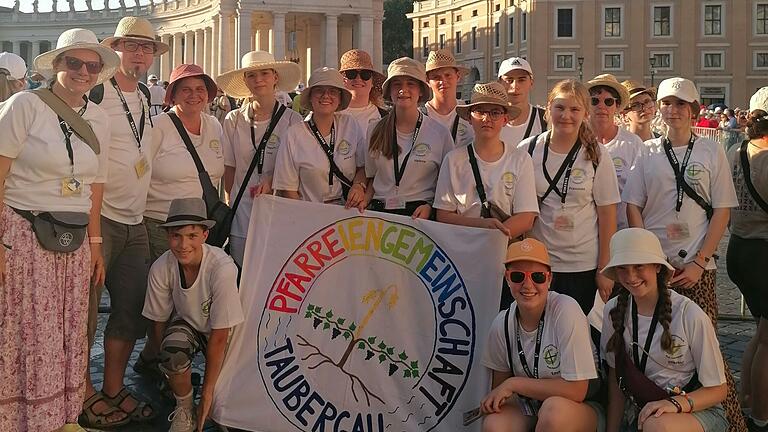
[600,228,728,432]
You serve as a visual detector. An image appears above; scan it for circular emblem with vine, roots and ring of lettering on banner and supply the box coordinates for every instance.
[257,216,476,432]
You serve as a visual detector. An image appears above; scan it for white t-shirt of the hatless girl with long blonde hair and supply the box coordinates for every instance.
[519,134,621,272]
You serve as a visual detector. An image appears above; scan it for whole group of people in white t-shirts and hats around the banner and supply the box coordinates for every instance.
[0,11,768,432]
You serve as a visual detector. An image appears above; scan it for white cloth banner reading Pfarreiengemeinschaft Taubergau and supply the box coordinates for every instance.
[212,196,506,432]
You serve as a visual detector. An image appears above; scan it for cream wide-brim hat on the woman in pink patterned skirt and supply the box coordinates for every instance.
[33,28,120,85]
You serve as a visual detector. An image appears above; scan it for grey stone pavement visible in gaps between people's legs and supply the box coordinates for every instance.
[91,233,755,432]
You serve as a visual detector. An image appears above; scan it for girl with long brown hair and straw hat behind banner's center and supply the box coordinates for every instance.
[360,57,453,219]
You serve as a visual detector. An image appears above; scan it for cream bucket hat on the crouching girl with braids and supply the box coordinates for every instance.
[601,228,675,281]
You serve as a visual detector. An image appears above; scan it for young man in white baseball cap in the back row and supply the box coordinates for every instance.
[499,57,547,146]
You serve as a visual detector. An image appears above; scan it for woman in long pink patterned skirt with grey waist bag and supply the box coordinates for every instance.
[0,29,118,432]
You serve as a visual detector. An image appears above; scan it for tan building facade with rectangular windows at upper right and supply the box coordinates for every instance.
[408,0,768,107]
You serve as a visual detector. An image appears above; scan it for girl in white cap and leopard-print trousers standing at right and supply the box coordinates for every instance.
[622,78,746,431]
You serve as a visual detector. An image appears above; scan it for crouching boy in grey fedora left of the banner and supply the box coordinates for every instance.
[142,198,244,432]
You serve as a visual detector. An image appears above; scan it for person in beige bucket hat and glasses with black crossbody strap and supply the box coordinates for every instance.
[273,67,365,206]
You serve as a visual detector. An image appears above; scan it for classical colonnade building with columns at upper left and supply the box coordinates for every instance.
[0,0,384,82]
